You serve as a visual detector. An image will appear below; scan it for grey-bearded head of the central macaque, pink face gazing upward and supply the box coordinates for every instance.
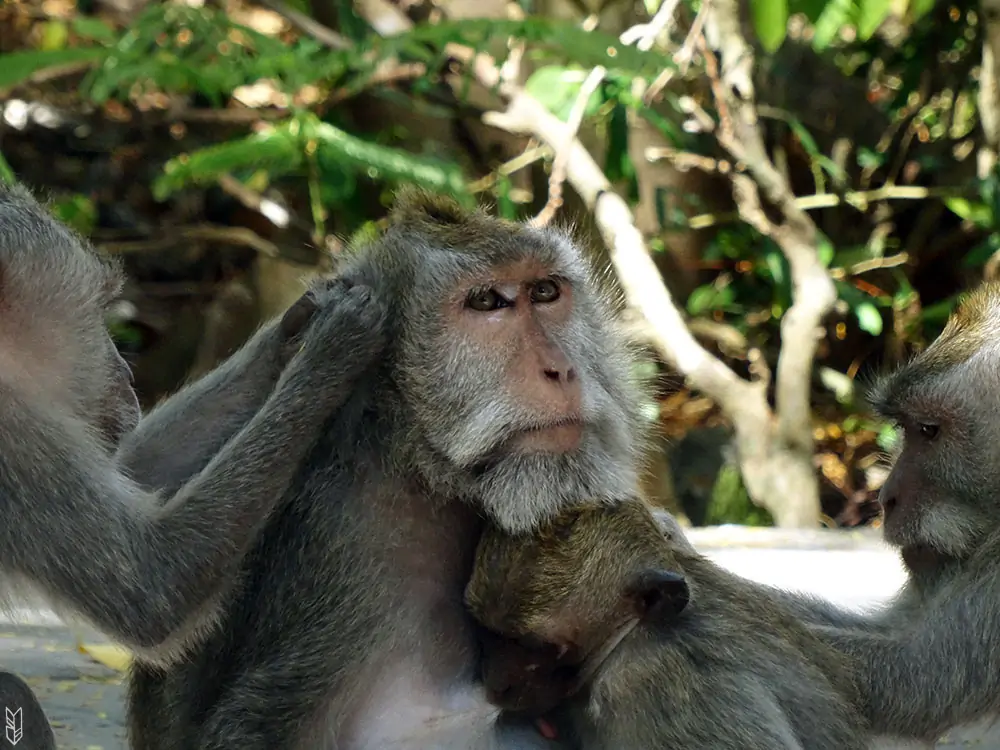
[345,193,644,531]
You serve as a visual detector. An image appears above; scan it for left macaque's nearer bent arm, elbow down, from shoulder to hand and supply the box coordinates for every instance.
[0,288,384,649]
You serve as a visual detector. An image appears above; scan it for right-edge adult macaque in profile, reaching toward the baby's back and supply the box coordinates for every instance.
[823,283,1000,741]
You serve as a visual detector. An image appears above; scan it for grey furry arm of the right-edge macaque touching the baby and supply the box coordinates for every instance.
[817,580,1000,740]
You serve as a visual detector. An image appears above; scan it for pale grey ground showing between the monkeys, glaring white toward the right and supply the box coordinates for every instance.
[0,527,1000,750]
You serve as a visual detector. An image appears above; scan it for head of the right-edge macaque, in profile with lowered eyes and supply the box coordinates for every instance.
[871,283,1000,569]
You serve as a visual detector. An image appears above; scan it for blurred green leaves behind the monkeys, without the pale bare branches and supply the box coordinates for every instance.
[0,0,1000,524]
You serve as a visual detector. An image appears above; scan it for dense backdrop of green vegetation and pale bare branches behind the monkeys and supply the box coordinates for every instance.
[0,0,984,526]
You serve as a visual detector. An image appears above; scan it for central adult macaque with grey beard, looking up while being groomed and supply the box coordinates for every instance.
[130,194,643,750]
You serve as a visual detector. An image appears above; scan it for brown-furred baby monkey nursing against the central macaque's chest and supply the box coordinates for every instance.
[465,500,867,750]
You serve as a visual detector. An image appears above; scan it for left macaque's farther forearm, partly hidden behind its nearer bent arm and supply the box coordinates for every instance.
[118,320,284,493]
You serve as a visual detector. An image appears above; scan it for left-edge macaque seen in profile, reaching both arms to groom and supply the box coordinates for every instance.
[0,187,385,661]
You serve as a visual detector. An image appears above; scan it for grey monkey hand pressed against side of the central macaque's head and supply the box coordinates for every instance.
[279,279,388,406]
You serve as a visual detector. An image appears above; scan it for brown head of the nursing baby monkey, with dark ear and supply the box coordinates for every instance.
[466,500,689,714]
